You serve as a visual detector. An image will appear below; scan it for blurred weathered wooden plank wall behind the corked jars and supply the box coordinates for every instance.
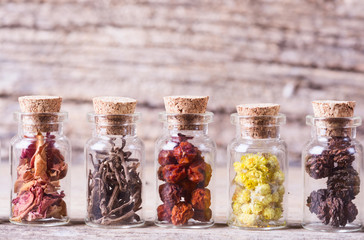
[0,0,364,165]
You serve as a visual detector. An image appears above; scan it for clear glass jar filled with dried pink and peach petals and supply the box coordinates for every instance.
[10,112,71,226]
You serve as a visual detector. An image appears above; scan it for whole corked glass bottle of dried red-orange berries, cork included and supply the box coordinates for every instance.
[155,96,216,228]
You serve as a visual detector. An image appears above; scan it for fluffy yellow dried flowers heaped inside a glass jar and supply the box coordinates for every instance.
[232,153,285,227]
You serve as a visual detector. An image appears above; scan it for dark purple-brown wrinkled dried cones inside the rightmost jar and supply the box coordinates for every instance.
[306,137,360,227]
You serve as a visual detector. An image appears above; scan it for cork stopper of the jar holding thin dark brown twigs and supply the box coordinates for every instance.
[93,96,137,135]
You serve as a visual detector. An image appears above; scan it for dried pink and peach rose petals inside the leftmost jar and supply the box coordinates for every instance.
[11,133,68,222]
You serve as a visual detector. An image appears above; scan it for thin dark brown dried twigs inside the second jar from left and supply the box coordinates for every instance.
[88,139,142,225]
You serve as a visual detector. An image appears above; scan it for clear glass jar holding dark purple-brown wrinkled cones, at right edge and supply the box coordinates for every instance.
[302,116,363,232]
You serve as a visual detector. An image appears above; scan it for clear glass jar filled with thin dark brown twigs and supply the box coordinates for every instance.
[85,113,145,228]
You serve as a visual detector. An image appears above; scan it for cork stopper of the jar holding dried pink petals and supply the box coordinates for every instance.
[18,96,62,133]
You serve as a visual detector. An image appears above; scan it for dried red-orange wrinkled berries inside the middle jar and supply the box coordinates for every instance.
[157,134,212,225]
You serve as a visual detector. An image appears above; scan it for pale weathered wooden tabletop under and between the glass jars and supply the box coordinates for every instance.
[0,164,364,240]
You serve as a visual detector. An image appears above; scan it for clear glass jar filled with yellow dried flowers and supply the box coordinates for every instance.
[228,113,287,230]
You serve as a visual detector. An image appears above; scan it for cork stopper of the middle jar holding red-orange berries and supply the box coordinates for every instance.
[164,96,209,130]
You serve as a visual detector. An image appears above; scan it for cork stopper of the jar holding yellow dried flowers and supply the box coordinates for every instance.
[236,103,280,139]
